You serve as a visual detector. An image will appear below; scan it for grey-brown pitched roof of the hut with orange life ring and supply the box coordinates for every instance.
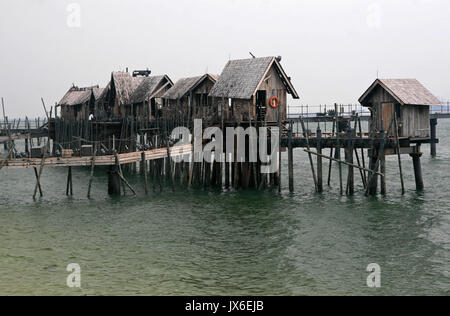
[209,57,298,99]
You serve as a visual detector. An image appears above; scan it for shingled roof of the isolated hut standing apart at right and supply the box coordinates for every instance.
[359,79,442,105]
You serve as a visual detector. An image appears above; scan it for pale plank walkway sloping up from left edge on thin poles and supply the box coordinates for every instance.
[0,144,192,169]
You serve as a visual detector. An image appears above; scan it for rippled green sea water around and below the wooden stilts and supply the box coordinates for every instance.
[0,120,450,295]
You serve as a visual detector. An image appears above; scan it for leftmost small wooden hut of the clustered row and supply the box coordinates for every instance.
[57,86,102,121]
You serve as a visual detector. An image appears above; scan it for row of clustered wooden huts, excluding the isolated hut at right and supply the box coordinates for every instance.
[57,57,299,123]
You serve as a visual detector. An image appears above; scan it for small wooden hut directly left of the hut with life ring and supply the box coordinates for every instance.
[163,74,219,120]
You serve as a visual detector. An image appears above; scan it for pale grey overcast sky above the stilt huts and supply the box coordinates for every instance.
[0,0,450,117]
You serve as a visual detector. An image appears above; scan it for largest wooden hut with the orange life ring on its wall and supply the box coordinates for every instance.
[209,57,299,123]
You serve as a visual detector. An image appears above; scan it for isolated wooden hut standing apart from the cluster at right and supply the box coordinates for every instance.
[359,79,442,138]
